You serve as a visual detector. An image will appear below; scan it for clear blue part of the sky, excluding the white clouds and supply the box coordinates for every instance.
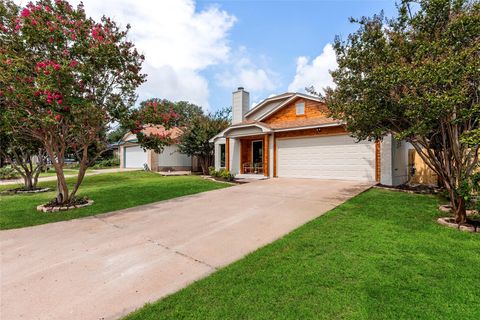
[197,0,396,108]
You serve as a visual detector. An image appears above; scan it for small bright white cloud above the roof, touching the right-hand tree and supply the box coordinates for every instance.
[288,44,338,91]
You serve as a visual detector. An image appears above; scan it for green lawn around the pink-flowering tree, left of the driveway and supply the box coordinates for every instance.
[0,171,228,229]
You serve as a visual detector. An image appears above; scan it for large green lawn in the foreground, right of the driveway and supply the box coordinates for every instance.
[126,189,480,320]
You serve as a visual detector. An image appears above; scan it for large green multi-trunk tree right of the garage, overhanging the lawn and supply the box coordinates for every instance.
[325,0,480,223]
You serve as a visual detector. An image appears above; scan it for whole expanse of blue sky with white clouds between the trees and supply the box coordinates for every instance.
[16,0,396,111]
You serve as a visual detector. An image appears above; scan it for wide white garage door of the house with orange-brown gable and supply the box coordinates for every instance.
[277,135,375,181]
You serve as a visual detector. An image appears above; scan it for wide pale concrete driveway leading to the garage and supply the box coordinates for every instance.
[0,179,370,320]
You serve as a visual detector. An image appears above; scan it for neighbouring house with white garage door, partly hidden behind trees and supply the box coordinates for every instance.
[119,126,192,171]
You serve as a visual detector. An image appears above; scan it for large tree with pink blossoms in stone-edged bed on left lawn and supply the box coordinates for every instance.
[0,0,145,205]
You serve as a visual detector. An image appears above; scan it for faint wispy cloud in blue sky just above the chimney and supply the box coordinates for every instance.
[215,47,278,92]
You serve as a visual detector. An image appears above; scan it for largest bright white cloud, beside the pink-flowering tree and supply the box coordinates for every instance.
[66,0,236,107]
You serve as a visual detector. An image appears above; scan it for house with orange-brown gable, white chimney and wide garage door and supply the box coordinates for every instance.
[210,87,436,185]
